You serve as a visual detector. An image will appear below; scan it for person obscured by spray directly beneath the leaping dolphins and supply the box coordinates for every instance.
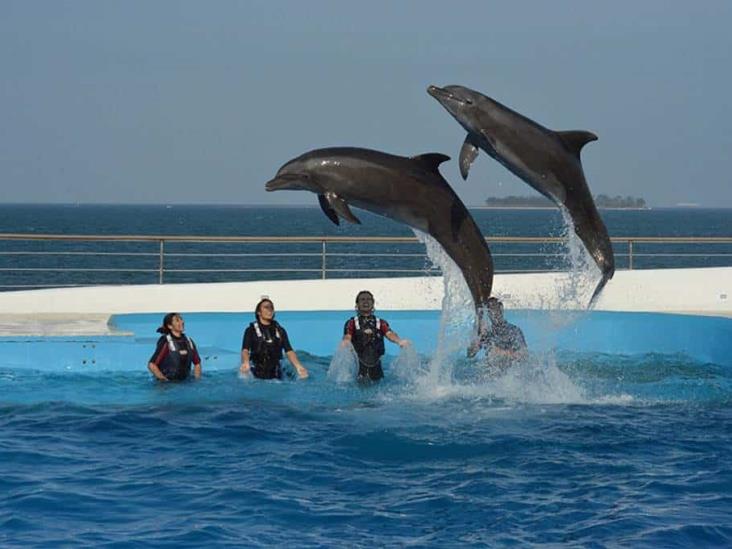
[468,297,529,369]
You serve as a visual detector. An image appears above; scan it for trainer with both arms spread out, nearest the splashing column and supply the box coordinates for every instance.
[342,290,409,382]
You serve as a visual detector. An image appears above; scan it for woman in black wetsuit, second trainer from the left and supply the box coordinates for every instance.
[239,298,308,379]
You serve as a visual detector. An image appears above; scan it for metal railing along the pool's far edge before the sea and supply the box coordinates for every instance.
[0,234,732,289]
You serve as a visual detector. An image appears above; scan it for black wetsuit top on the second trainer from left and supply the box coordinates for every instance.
[241,321,292,379]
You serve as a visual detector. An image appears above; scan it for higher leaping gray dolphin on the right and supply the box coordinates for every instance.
[427,86,615,306]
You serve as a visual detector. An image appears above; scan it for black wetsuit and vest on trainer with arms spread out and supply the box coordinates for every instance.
[343,315,391,381]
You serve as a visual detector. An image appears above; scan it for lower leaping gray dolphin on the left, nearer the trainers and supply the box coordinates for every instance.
[265,147,493,325]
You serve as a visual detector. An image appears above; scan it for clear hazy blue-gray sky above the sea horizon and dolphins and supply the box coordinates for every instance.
[0,0,732,207]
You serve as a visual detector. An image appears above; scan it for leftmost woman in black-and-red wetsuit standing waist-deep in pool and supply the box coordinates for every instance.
[147,313,201,381]
